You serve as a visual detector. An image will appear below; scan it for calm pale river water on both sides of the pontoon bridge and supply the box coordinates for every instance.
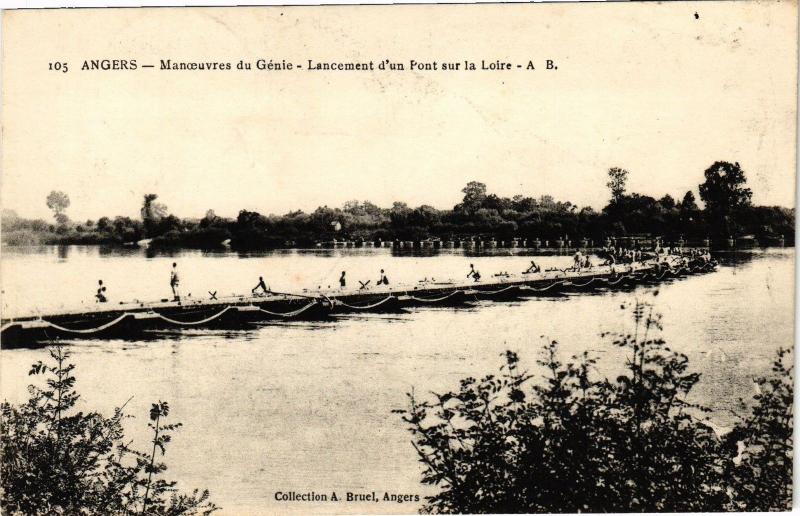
[0,247,795,514]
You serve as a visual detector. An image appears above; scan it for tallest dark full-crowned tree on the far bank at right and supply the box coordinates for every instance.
[700,161,753,236]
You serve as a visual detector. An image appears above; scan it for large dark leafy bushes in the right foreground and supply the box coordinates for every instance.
[398,303,792,513]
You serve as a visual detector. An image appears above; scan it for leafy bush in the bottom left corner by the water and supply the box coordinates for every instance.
[0,347,217,515]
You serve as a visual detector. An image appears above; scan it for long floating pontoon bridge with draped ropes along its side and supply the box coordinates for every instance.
[0,260,715,348]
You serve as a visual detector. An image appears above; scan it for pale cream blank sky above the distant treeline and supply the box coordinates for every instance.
[0,2,797,220]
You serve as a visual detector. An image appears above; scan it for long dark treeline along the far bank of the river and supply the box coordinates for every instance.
[3,162,794,249]
